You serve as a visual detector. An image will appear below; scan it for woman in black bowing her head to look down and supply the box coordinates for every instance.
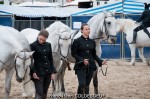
[30,29,57,99]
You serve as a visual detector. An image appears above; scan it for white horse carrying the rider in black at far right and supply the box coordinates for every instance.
[109,19,150,65]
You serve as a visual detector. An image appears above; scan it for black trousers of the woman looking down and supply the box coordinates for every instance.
[33,74,51,99]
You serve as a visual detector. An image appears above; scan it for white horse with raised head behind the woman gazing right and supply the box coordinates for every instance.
[64,11,118,94]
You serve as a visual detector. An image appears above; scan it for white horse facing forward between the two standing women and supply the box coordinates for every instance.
[21,21,74,94]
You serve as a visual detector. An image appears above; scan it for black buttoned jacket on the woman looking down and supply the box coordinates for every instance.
[30,40,56,76]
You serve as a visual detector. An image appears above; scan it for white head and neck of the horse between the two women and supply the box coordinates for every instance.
[47,21,74,60]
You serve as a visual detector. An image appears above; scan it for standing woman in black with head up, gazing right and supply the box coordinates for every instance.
[71,24,106,99]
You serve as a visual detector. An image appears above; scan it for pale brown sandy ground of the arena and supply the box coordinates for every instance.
[0,60,150,99]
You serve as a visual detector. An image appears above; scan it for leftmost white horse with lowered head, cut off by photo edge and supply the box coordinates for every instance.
[0,26,33,99]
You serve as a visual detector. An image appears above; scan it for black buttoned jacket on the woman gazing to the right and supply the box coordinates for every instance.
[71,36,103,70]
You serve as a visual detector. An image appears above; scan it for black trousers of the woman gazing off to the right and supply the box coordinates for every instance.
[76,68,95,99]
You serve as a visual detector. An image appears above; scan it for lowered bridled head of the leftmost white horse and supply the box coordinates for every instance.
[15,50,34,82]
